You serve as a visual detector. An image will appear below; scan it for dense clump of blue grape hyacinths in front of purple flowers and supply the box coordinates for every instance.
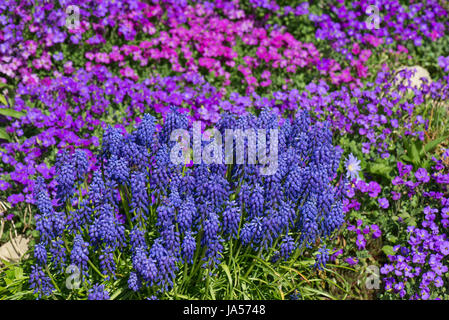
[31,108,346,299]
